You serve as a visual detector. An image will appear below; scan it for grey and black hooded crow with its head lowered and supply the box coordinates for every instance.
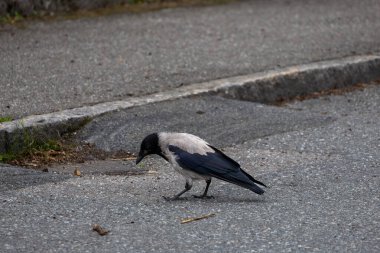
[136,132,267,200]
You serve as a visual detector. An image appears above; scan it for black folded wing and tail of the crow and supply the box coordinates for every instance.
[169,145,265,194]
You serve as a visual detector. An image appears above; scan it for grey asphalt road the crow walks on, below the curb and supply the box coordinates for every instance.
[0,85,380,252]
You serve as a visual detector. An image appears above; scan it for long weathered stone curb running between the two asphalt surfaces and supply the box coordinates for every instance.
[0,55,380,152]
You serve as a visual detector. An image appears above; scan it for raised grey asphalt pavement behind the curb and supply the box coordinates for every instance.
[0,0,380,118]
